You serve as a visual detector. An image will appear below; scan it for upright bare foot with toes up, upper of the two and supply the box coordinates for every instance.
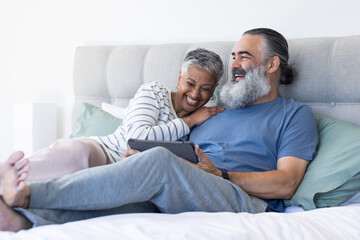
[0,151,30,207]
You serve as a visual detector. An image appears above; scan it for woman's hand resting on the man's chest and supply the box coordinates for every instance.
[182,106,225,128]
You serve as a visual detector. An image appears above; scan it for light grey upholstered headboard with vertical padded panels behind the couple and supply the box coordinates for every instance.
[73,36,360,126]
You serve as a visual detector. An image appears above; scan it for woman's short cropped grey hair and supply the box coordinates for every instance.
[181,48,224,83]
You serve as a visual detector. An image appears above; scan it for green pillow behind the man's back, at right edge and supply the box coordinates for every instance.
[284,114,360,210]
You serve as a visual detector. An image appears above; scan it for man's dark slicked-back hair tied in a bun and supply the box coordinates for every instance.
[243,28,294,84]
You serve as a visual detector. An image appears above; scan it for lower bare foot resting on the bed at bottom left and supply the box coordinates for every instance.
[0,198,32,232]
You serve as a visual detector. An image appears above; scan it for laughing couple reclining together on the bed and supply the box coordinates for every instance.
[0,28,318,231]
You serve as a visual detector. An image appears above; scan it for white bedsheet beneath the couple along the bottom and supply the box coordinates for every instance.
[0,204,360,240]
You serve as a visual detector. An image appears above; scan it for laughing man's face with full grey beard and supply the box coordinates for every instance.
[220,35,271,108]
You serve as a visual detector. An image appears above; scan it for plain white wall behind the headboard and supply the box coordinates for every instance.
[0,0,360,159]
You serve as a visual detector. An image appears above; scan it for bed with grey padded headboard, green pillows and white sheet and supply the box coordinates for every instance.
[0,36,360,240]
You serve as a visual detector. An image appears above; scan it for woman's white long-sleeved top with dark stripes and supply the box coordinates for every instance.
[95,82,190,162]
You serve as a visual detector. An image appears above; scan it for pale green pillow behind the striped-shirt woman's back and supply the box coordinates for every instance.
[70,103,122,138]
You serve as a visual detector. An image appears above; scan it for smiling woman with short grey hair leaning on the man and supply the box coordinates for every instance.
[17,49,224,181]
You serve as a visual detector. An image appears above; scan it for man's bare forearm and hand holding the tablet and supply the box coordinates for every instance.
[195,146,309,199]
